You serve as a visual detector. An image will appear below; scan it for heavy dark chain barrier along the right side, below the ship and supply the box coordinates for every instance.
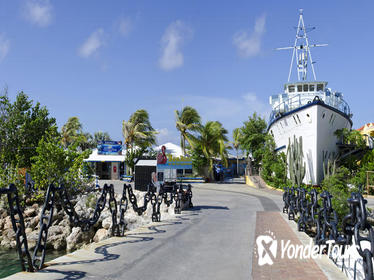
[283,187,374,279]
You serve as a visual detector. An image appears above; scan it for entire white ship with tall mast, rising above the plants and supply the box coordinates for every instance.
[268,10,352,185]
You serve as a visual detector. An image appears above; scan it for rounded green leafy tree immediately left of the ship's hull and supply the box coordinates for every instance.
[239,113,267,167]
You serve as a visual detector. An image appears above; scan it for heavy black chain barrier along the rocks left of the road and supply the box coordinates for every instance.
[0,179,192,272]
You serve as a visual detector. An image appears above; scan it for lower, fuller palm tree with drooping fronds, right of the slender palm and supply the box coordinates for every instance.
[190,121,228,178]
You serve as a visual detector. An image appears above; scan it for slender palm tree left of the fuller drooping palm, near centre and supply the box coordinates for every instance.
[174,106,201,155]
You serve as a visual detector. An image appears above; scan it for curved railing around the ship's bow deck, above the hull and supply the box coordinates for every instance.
[269,91,351,124]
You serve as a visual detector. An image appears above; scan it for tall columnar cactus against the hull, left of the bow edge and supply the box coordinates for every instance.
[287,135,306,187]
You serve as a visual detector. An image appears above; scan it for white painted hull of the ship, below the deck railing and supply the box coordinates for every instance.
[269,103,352,185]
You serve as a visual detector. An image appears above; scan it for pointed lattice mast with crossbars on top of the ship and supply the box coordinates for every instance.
[276,9,327,82]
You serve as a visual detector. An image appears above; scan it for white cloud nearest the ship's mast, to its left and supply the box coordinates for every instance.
[233,14,266,57]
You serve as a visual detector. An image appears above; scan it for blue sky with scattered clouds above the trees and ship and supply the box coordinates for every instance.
[0,0,374,143]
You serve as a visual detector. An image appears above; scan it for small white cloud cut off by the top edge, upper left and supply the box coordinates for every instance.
[23,0,53,27]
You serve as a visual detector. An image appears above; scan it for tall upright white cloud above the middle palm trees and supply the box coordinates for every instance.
[159,20,192,71]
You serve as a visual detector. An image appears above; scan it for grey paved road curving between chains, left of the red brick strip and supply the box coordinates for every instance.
[3,184,296,279]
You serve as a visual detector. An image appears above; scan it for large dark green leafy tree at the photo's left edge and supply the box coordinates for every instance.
[0,92,57,168]
